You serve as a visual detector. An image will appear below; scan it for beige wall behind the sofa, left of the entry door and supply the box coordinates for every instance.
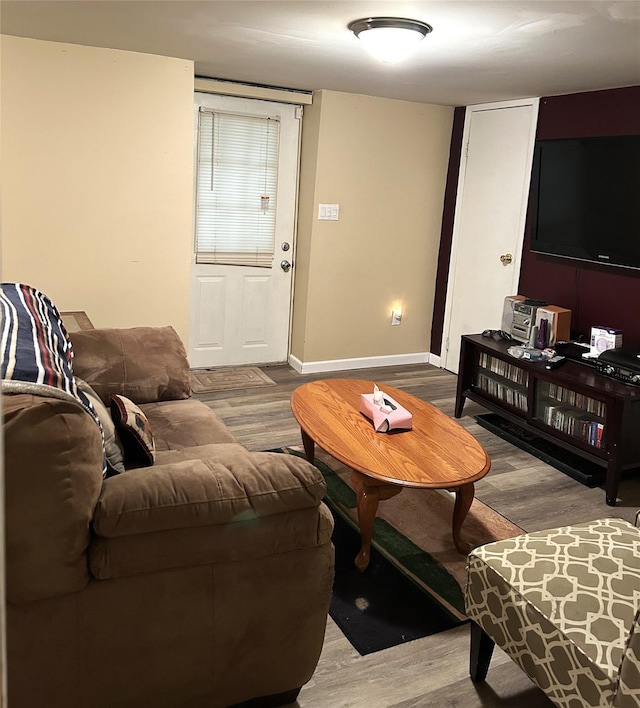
[0,36,194,342]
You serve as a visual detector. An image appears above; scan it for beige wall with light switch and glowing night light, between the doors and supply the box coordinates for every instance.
[292,91,453,363]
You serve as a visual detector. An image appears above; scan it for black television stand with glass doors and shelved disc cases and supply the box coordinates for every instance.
[455,334,640,506]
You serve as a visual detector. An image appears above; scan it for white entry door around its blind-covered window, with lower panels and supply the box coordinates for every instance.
[189,93,302,368]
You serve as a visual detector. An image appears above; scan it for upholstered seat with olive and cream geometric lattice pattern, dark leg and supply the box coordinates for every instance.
[465,519,640,708]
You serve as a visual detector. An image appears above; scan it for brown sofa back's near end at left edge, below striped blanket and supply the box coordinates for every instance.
[2,394,103,604]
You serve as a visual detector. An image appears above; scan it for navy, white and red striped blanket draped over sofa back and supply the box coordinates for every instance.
[0,283,106,474]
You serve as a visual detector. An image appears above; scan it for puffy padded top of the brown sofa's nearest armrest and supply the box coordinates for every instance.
[93,443,326,538]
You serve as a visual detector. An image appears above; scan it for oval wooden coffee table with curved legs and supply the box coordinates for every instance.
[291,379,491,571]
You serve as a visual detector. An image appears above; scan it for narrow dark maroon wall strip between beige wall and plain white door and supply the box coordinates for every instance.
[430,106,465,355]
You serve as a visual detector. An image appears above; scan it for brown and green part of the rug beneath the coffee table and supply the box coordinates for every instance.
[278,447,523,621]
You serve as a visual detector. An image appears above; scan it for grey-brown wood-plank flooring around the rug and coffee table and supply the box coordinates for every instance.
[197,364,640,708]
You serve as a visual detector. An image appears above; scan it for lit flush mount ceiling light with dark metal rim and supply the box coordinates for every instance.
[348,17,433,64]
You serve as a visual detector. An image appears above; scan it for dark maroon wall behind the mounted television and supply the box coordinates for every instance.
[518,86,640,350]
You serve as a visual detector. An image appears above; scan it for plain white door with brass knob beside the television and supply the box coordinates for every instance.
[441,98,538,373]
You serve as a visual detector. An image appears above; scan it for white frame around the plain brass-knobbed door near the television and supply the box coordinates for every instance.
[434,97,540,376]
